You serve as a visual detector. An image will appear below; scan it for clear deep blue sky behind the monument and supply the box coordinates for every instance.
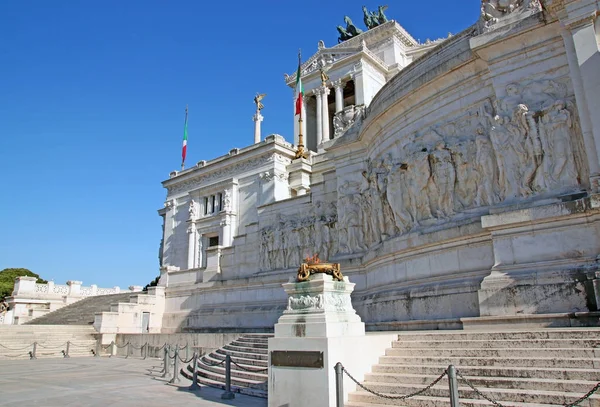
[0,0,480,287]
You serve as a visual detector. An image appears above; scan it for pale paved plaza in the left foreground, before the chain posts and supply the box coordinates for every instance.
[0,357,267,407]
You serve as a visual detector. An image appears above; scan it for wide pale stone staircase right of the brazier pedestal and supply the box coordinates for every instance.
[345,328,600,407]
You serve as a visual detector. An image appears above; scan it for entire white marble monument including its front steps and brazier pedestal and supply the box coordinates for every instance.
[3,0,600,407]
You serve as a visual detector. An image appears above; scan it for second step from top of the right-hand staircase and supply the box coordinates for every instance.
[392,337,600,349]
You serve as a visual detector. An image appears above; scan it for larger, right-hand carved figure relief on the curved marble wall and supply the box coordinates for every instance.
[337,80,585,253]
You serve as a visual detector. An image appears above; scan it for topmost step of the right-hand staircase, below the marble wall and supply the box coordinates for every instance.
[398,328,600,342]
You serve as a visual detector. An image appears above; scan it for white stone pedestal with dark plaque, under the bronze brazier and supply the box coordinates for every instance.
[269,274,370,407]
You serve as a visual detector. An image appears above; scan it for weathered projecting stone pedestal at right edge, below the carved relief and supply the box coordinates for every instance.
[478,195,600,317]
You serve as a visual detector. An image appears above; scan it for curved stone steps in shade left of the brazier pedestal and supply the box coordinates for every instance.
[182,334,273,398]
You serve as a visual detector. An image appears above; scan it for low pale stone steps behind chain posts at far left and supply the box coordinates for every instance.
[0,325,96,360]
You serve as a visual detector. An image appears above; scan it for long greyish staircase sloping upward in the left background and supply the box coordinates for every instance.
[26,292,132,325]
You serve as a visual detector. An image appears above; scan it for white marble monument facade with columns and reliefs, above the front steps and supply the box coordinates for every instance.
[159,0,600,332]
